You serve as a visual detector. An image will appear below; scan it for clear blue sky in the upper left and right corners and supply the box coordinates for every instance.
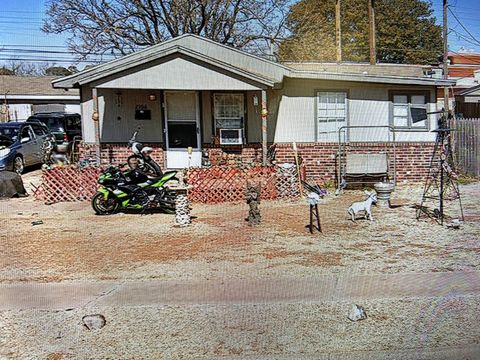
[0,0,480,69]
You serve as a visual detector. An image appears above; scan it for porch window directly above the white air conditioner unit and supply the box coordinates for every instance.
[213,94,244,132]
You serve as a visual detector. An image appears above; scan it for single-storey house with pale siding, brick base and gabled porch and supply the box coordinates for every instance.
[52,35,454,180]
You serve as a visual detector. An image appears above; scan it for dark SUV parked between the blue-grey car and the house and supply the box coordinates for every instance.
[27,112,82,153]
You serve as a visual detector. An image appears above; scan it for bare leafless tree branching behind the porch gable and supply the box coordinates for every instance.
[42,0,289,58]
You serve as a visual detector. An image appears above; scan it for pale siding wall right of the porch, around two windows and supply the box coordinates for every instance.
[269,79,436,143]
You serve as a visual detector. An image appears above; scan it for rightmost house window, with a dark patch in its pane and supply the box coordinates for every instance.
[392,93,427,129]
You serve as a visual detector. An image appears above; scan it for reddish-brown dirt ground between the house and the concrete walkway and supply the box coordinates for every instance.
[0,171,480,282]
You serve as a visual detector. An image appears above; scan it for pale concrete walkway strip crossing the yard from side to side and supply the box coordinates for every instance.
[0,271,480,310]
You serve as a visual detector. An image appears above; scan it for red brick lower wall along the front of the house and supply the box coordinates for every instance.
[80,143,434,182]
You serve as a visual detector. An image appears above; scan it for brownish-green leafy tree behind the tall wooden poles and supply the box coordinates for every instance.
[279,0,442,64]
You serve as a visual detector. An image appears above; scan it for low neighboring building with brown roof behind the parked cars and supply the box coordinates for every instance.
[0,75,80,121]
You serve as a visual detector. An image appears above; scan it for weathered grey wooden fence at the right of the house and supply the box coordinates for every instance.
[454,118,480,177]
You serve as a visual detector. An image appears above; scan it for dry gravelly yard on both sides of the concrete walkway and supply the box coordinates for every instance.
[0,171,480,360]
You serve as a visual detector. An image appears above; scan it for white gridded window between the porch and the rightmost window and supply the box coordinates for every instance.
[317,91,347,140]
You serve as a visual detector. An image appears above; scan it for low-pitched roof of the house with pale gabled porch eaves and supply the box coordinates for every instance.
[52,34,455,88]
